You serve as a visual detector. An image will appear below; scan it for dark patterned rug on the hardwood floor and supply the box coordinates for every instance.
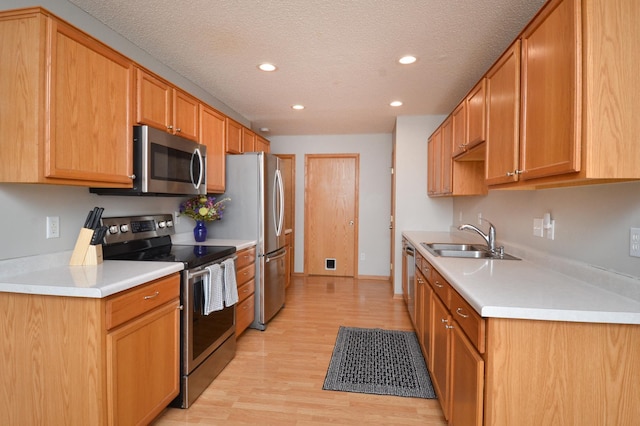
[322,326,436,399]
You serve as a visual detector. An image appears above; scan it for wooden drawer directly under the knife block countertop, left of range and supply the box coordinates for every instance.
[105,274,180,330]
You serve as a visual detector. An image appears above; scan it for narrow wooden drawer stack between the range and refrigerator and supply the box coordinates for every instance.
[236,247,256,338]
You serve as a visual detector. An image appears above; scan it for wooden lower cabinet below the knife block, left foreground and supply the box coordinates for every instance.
[0,273,180,425]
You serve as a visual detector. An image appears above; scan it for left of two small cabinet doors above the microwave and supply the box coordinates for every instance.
[136,68,173,131]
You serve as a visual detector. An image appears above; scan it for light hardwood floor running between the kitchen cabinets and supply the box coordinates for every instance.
[154,277,446,426]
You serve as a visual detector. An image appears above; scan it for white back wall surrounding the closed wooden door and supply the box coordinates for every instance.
[269,134,391,276]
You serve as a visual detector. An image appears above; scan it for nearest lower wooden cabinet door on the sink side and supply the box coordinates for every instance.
[450,322,484,426]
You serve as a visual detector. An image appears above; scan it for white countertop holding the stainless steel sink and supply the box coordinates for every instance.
[402,231,640,324]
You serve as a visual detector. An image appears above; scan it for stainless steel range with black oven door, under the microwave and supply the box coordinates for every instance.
[102,214,236,408]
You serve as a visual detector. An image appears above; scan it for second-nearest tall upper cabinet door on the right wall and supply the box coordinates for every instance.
[486,40,520,185]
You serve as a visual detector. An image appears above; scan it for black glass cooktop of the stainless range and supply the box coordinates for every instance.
[103,236,236,269]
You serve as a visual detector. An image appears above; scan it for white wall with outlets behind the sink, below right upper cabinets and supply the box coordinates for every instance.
[453,182,640,279]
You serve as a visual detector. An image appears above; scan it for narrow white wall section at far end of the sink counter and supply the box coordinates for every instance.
[394,115,453,294]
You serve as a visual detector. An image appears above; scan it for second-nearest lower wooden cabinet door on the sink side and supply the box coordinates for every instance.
[430,296,451,419]
